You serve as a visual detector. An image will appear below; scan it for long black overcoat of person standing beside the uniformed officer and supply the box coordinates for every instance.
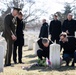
[14,18,24,46]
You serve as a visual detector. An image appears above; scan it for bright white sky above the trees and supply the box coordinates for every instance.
[0,0,74,17]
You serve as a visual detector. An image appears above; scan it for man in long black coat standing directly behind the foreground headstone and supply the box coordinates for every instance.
[49,14,61,43]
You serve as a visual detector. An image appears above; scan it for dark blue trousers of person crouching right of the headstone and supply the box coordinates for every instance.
[63,52,76,64]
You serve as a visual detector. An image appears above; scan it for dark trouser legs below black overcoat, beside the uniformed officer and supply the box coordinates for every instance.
[13,44,22,63]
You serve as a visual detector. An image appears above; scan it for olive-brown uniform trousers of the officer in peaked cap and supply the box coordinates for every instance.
[5,38,13,65]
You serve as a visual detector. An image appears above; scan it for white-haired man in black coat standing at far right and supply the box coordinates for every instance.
[62,13,76,36]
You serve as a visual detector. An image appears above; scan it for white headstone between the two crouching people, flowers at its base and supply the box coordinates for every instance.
[49,43,60,68]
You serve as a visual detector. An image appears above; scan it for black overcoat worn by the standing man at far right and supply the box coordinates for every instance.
[62,19,76,36]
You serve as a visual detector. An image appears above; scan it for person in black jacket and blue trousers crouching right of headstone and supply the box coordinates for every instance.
[60,33,76,66]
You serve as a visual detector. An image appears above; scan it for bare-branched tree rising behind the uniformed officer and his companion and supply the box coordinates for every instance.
[0,0,45,31]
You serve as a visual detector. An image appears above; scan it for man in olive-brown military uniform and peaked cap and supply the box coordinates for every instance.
[3,8,21,66]
